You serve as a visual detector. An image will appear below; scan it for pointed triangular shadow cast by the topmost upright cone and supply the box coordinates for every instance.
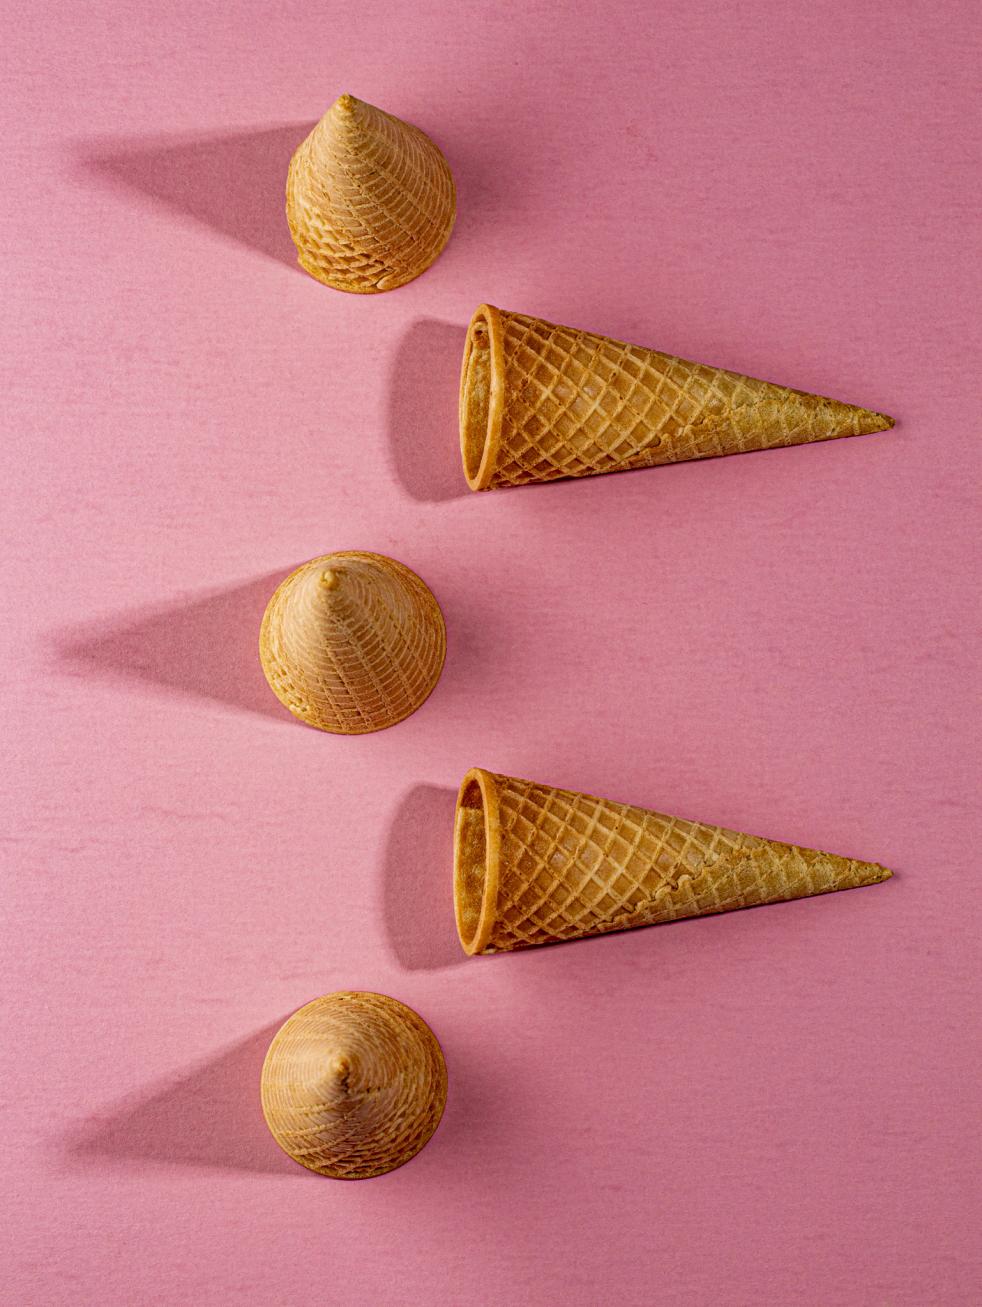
[77,123,313,272]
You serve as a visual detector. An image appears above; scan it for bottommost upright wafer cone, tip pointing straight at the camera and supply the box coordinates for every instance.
[262,992,447,1180]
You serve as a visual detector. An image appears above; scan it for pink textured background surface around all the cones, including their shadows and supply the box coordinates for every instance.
[0,0,982,1307]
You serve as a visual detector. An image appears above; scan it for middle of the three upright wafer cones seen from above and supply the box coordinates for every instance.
[259,552,447,735]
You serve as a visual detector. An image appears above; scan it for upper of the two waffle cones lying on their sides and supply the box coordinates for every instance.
[460,305,893,490]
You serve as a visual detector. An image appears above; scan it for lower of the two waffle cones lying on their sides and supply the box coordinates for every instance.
[454,767,892,954]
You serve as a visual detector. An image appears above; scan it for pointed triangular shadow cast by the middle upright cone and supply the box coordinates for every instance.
[54,571,290,724]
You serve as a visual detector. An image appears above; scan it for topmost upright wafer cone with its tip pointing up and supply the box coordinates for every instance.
[286,95,456,294]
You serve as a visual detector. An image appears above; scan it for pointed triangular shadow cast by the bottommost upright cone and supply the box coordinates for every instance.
[67,1022,301,1175]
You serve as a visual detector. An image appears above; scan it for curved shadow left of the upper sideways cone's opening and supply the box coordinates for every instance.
[388,318,471,503]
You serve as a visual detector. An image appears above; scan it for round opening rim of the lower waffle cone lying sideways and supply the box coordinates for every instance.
[454,767,501,957]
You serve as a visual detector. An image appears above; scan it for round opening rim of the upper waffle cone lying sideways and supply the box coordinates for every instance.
[460,305,505,490]
